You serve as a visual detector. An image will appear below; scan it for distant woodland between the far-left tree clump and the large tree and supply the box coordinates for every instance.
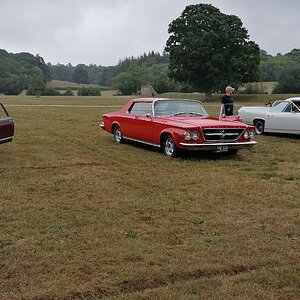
[48,51,176,94]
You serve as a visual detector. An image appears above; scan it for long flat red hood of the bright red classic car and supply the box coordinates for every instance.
[161,116,247,128]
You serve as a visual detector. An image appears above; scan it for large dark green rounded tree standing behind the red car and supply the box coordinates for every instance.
[165,4,260,98]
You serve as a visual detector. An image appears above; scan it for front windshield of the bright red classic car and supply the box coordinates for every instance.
[154,100,208,116]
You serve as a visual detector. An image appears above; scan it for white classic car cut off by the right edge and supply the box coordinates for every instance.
[238,97,300,134]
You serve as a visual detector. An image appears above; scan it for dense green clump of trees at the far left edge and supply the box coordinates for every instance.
[0,49,51,95]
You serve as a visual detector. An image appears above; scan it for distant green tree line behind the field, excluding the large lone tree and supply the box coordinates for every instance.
[0,49,300,95]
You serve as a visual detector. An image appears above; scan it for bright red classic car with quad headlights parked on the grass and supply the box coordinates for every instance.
[100,98,256,157]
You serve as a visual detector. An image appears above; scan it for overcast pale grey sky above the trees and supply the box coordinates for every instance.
[0,0,300,66]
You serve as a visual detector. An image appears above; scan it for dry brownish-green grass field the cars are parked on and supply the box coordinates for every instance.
[0,93,300,300]
